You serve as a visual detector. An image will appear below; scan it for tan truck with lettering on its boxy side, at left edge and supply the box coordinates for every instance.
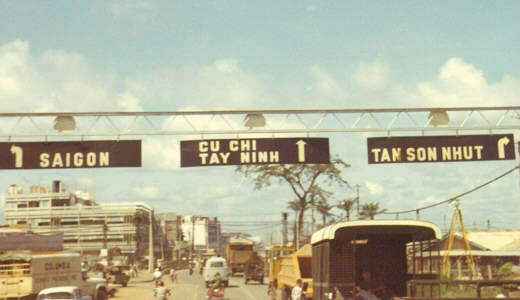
[0,251,114,300]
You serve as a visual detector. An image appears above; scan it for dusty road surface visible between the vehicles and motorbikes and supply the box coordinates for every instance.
[110,270,269,300]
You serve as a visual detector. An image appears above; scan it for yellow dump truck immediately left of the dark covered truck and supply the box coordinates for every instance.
[268,244,312,300]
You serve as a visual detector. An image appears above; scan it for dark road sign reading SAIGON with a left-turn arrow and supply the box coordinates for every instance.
[0,140,141,169]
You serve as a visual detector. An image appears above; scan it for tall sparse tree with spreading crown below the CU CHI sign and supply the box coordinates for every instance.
[236,158,350,246]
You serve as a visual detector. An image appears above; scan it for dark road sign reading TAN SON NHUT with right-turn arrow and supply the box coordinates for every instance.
[367,134,515,164]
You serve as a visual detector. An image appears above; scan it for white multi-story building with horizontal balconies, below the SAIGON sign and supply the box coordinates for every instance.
[4,181,153,260]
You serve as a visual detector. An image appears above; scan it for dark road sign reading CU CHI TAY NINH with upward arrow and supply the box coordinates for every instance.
[181,138,330,167]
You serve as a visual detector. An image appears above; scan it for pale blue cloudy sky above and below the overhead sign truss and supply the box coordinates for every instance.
[0,0,520,239]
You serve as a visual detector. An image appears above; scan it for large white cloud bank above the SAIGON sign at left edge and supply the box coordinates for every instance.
[0,40,143,112]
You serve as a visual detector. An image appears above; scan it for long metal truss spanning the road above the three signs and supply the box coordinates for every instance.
[0,106,520,140]
